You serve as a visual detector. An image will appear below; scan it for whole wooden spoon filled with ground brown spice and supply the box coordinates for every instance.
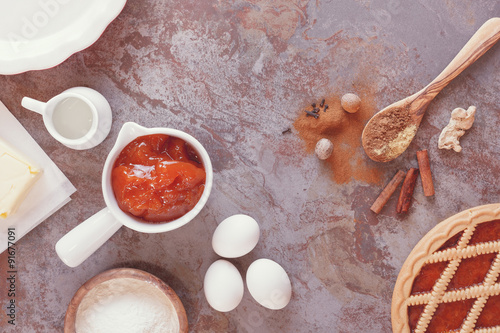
[361,17,500,162]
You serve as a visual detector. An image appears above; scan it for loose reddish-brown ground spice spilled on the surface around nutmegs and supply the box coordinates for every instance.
[293,91,382,184]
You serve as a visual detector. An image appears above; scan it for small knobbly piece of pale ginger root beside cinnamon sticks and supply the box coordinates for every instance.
[438,106,476,153]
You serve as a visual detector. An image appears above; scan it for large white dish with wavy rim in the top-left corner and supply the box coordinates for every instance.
[0,0,126,74]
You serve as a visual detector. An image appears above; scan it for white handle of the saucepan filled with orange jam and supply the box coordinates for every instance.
[56,208,122,267]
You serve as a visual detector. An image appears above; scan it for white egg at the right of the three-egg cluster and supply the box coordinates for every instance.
[246,259,292,310]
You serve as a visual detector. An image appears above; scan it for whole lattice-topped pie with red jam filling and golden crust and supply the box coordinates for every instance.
[391,204,500,333]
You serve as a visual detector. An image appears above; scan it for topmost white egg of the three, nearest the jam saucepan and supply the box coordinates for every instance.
[212,214,260,258]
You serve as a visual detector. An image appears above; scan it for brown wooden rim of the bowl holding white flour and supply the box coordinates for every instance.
[64,268,188,333]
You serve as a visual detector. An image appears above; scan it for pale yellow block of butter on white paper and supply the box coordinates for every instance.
[0,138,41,219]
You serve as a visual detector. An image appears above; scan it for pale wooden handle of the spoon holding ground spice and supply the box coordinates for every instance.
[424,17,500,99]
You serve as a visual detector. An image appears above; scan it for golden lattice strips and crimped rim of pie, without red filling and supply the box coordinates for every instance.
[391,204,500,333]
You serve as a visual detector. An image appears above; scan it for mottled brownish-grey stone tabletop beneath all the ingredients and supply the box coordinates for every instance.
[0,0,500,333]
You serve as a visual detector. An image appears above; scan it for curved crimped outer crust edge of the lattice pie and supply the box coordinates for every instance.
[391,203,500,333]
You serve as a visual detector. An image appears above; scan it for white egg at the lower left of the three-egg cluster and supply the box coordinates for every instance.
[203,259,244,312]
